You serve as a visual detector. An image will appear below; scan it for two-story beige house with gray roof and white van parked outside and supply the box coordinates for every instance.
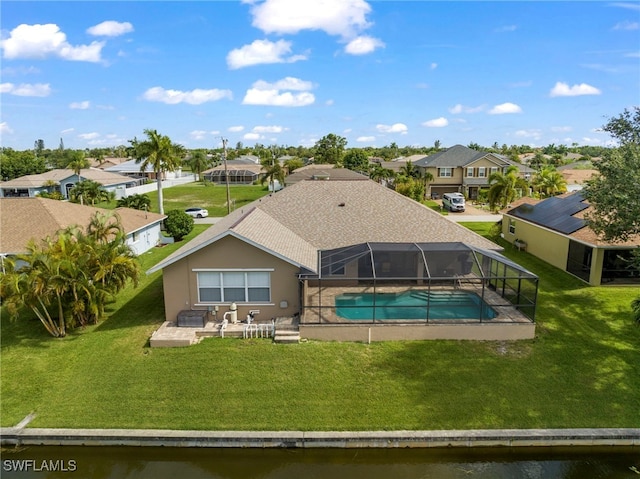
[414,145,535,200]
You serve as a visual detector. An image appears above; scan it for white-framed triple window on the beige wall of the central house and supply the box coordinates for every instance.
[196,270,271,303]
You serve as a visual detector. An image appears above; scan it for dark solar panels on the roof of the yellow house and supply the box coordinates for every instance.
[510,193,589,234]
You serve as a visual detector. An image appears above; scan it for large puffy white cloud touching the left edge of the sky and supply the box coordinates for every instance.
[0,23,105,62]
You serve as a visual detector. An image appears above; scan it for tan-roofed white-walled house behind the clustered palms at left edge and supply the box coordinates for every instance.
[0,198,166,256]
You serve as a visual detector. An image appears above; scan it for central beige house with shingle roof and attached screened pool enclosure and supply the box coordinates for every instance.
[149,176,537,340]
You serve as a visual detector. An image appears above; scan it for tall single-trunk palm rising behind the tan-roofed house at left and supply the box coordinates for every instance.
[129,129,184,214]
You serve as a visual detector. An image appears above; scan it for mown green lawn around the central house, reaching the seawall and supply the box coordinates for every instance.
[0,224,640,430]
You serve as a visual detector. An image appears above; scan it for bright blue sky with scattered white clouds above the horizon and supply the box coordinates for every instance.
[0,0,640,149]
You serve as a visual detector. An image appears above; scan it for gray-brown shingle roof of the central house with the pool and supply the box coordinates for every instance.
[150,180,501,272]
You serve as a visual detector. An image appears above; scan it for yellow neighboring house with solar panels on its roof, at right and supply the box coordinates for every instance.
[502,191,640,286]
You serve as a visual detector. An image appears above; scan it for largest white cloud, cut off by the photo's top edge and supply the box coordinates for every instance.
[251,0,371,38]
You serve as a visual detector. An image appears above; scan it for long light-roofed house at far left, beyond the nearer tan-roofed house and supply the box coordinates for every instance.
[0,168,138,198]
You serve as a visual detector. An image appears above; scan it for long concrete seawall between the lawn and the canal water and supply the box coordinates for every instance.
[0,427,640,448]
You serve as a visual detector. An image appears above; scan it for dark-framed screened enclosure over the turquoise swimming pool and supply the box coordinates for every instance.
[300,243,538,324]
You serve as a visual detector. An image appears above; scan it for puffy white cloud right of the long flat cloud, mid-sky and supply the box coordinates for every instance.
[242,77,316,107]
